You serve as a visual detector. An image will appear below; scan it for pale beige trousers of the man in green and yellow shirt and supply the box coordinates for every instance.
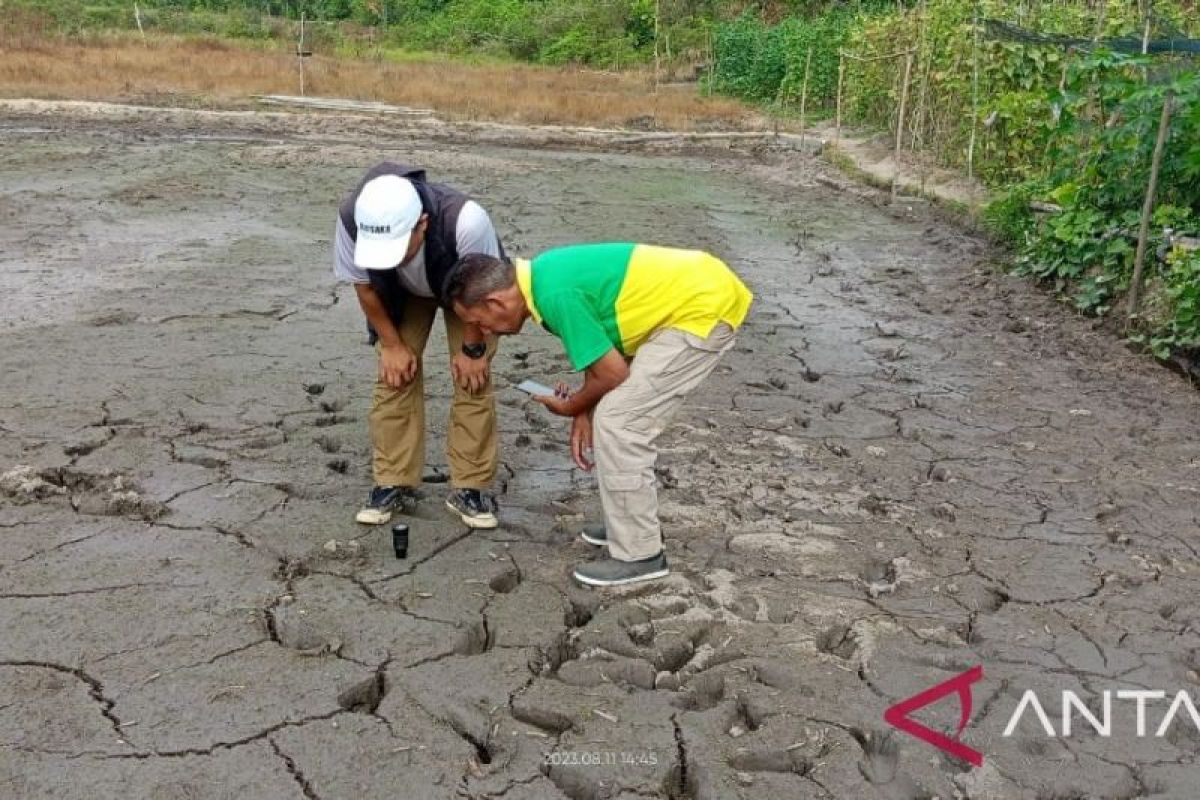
[592,323,736,561]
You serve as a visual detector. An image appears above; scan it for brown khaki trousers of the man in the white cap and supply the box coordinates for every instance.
[370,295,498,489]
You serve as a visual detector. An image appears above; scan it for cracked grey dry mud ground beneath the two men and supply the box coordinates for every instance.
[0,106,1200,800]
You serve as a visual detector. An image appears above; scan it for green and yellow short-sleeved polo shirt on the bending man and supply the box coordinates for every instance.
[516,242,754,369]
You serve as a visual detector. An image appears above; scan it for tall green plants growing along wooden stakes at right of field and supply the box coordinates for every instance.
[710,0,1200,357]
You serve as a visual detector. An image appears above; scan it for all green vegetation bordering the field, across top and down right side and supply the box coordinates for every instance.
[9,0,1200,356]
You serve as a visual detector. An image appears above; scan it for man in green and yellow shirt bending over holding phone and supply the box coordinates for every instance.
[446,243,754,587]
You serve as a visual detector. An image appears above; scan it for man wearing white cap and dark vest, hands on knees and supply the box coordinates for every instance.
[334,162,504,528]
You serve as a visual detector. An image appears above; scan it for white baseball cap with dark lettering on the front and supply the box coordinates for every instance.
[354,175,422,270]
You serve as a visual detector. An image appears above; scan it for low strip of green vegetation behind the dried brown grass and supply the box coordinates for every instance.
[4,0,724,68]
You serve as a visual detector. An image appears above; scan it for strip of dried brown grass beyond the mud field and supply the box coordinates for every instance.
[0,29,762,131]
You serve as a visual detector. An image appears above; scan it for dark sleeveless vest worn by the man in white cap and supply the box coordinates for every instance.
[338,161,504,343]
